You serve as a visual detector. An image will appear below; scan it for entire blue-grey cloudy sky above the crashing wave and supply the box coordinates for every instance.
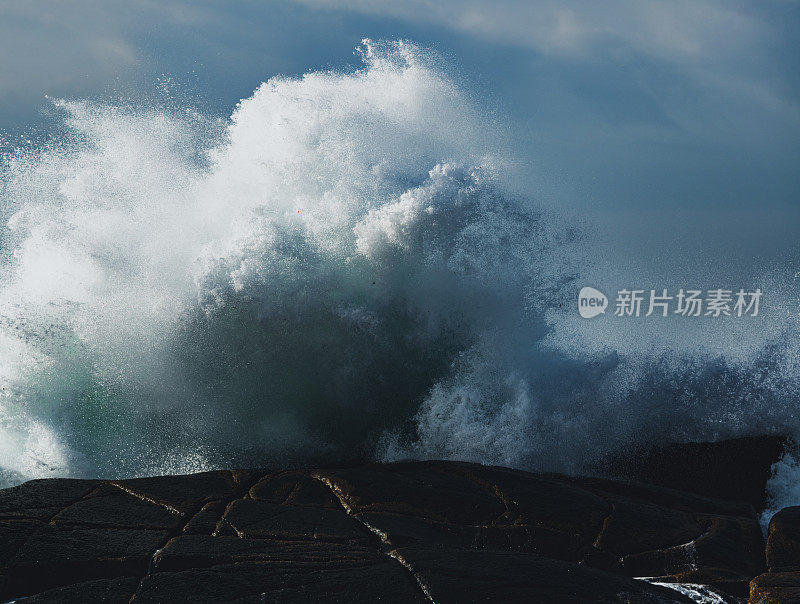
[0,0,800,287]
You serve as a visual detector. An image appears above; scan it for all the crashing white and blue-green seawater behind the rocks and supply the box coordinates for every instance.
[0,41,800,516]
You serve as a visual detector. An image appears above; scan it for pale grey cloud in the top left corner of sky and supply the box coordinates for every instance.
[0,0,231,121]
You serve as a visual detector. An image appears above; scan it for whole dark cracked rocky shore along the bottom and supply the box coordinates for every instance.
[0,441,800,603]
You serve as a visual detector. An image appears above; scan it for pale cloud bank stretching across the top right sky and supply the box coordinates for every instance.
[295,0,800,125]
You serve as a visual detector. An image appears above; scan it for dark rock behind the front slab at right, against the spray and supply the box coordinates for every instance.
[594,436,789,510]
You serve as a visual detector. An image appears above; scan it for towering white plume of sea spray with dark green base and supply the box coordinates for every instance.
[0,43,546,479]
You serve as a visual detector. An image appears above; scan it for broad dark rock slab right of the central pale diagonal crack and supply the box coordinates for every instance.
[322,462,764,589]
